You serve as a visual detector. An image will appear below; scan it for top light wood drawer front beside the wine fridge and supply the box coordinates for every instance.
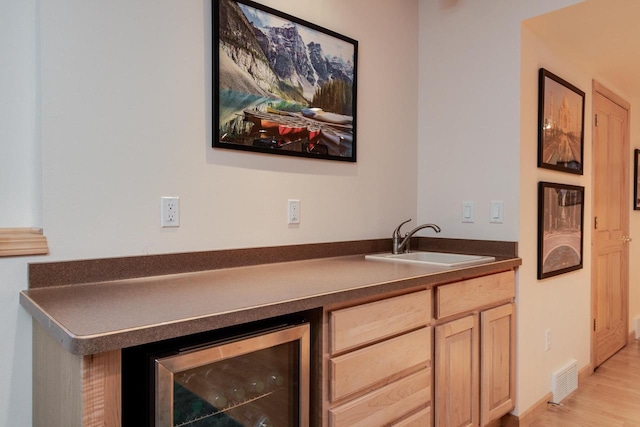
[329,290,431,354]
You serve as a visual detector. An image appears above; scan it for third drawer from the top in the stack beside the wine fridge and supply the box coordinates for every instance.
[329,369,431,427]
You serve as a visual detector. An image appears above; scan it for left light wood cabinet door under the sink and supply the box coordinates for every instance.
[434,314,480,427]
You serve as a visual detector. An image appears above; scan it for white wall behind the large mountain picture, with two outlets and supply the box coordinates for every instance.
[0,0,418,426]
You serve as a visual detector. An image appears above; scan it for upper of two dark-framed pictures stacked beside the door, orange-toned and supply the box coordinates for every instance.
[538,68,585,175]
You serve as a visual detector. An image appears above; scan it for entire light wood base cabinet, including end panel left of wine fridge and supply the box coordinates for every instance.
[33,270,515,427]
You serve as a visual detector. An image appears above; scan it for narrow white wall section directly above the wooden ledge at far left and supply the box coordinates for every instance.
[0,0,41,227]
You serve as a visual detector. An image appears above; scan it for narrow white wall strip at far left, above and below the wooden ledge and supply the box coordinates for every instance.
[0,0,42,426]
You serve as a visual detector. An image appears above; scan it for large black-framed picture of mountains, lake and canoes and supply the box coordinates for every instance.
[212,0,358,162]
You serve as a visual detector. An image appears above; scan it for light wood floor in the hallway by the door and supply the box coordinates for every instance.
[530,340,640,427]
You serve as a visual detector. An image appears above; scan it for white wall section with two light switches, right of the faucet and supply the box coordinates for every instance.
[418,0,579,241]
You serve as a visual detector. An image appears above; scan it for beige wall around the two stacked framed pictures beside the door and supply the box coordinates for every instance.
[517,26,591,412]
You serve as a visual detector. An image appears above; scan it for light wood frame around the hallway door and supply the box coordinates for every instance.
[589,79,631,372]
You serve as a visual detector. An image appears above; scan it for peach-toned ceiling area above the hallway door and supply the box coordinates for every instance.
[524,0,640,101]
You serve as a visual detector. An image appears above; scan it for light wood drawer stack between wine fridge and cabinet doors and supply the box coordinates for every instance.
[323,289,432,427]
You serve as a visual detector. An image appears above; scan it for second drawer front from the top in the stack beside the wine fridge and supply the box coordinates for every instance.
[329,328,431,402]
